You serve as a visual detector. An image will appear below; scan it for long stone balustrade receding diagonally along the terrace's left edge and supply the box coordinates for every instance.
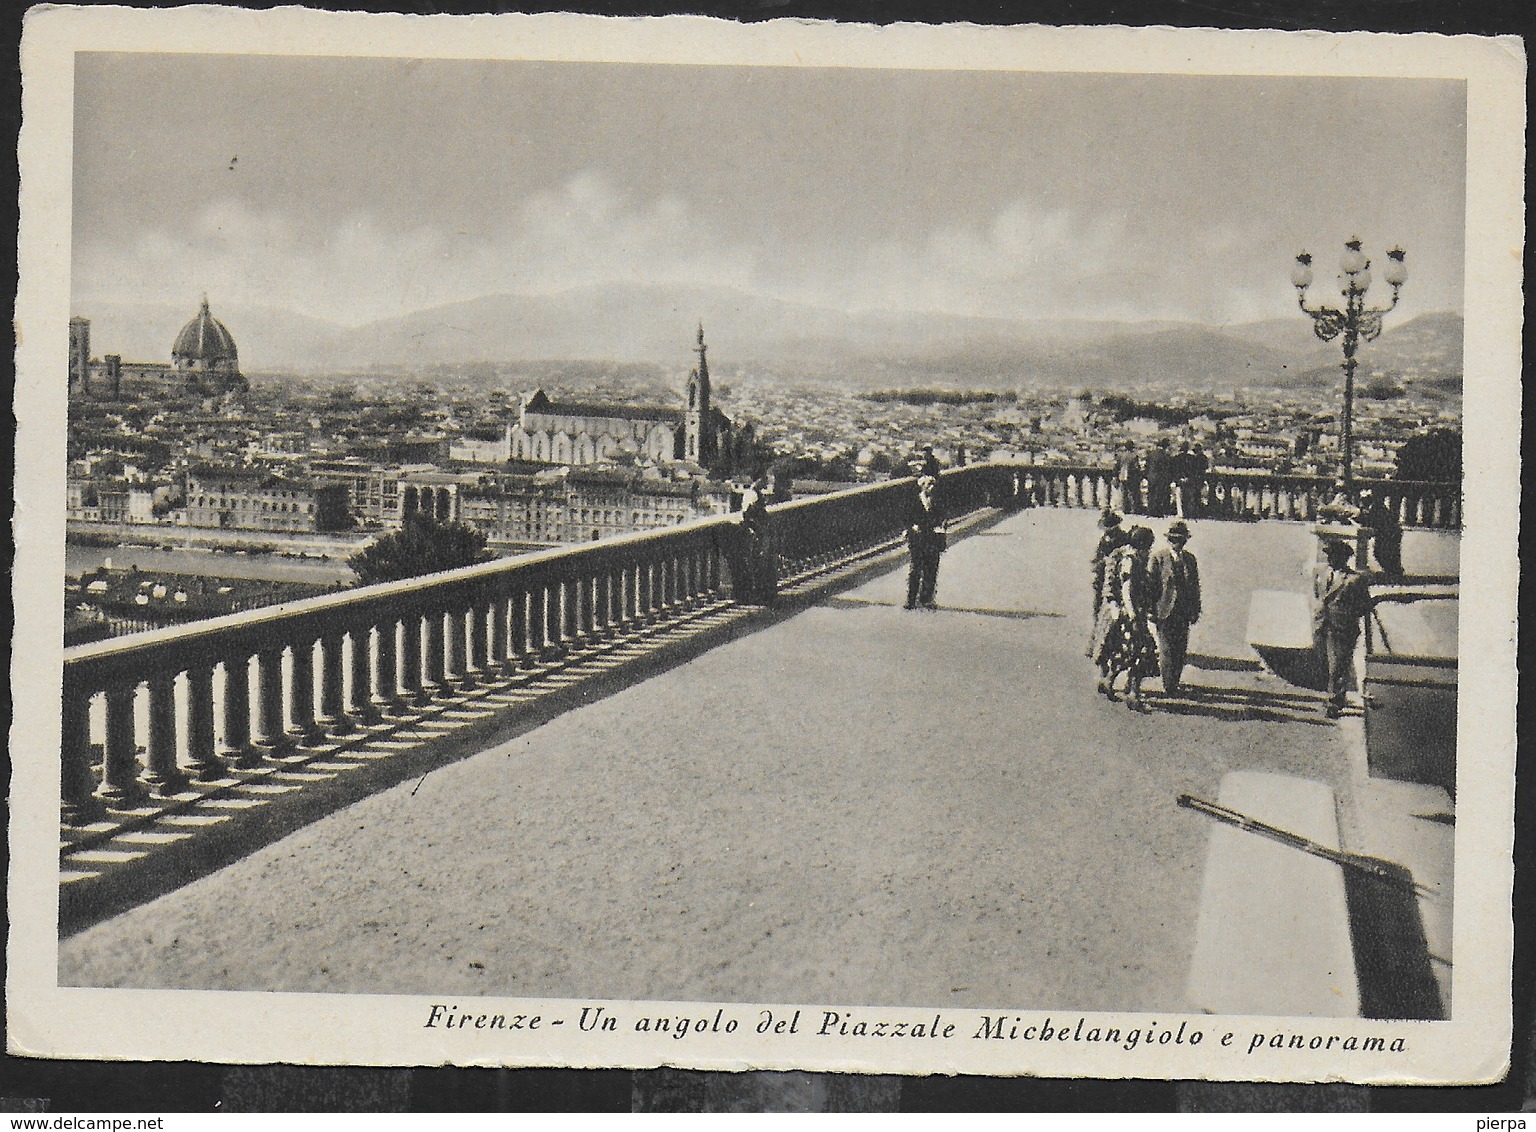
[60,465,1014,826]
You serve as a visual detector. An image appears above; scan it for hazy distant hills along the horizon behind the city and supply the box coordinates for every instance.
[77,284,1462,390]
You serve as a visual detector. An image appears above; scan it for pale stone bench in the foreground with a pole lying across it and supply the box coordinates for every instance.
[1189,771,1359,1017]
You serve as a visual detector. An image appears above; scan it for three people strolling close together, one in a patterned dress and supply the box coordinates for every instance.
[1087,510,1200,711]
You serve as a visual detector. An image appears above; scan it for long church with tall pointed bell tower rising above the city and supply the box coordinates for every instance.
[507,326,731,467]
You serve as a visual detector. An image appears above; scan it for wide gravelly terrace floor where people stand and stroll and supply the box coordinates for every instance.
[60,510,1382,1011]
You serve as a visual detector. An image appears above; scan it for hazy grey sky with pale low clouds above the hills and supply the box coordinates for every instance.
[72,54,1465,324]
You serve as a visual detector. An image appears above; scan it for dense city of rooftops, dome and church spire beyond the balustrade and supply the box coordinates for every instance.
[68,301,1461,628]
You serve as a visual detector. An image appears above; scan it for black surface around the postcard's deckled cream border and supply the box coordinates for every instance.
[0,0,1536,1114]
